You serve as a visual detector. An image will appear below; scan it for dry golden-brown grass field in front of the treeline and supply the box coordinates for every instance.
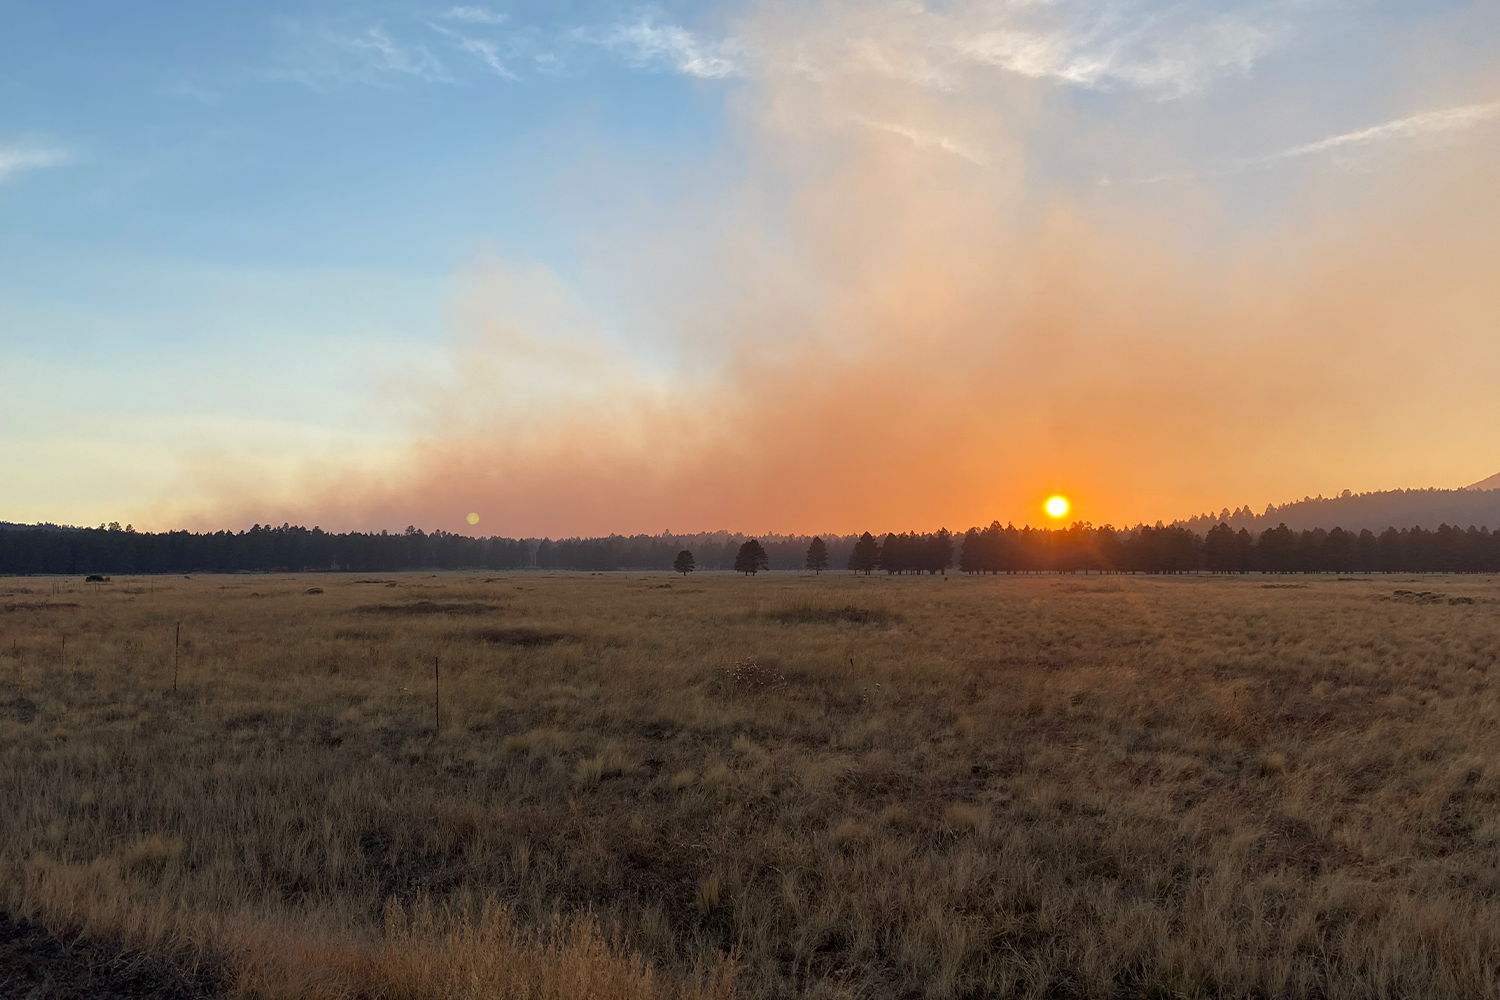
[0,574,1500,1000]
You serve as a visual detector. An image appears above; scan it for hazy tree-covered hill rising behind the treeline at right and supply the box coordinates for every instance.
[1178,475,1500,534]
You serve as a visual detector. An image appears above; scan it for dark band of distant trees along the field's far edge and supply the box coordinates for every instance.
[0,522,1500,576]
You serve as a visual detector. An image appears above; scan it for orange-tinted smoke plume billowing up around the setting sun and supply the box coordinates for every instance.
[178,3,1500,537]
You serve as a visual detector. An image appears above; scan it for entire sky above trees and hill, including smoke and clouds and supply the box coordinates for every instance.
[0,0,1500,537]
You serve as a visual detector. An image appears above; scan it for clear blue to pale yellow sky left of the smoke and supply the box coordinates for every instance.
[0,3,744,519]
